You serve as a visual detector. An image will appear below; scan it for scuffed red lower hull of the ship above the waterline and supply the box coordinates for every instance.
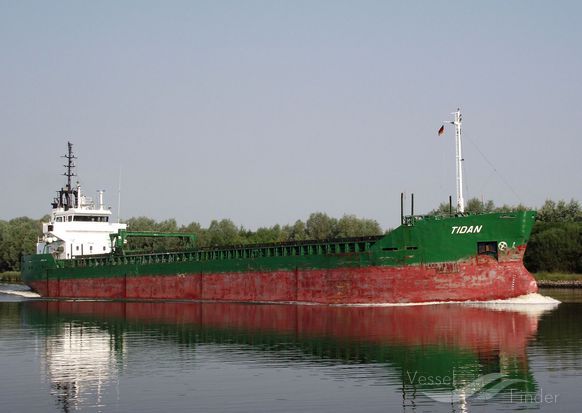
[30,257,537,304]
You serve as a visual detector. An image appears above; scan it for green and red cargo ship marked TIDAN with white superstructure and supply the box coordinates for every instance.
[21,110,537,304]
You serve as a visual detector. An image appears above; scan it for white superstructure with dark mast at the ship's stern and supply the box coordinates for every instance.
[36,142,127,259]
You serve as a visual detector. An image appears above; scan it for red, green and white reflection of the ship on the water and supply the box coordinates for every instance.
[18,301,560,412]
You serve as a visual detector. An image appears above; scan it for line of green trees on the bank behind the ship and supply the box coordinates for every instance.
[0,198,582,273]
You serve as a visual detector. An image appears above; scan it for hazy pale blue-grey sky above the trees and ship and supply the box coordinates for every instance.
[0,1,582,228]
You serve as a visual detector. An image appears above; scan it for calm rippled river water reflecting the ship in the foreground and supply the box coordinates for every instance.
[0,285,582,413]
